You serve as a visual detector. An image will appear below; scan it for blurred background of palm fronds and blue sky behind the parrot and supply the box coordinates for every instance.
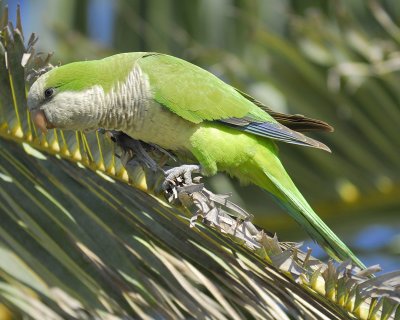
[5,0,400,271]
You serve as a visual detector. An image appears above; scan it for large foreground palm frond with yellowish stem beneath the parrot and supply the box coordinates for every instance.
[0,3,400,319]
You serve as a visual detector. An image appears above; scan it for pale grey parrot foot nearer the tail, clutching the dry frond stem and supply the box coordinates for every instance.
[162,164,201,191]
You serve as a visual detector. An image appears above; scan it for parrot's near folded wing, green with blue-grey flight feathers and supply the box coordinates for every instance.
[138,53,329,151]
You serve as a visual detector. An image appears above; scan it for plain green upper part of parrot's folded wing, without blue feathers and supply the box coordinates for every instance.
[138,54,276,123]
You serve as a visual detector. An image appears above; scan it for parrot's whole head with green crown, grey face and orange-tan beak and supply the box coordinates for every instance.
[27,62,106,132]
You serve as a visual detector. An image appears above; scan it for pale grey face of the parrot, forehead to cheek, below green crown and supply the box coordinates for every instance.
[28,74,99,132]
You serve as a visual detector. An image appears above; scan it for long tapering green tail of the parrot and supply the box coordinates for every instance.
[250,145,366,269]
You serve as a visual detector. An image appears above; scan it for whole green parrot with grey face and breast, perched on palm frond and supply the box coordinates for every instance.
[28,52,365,268]
